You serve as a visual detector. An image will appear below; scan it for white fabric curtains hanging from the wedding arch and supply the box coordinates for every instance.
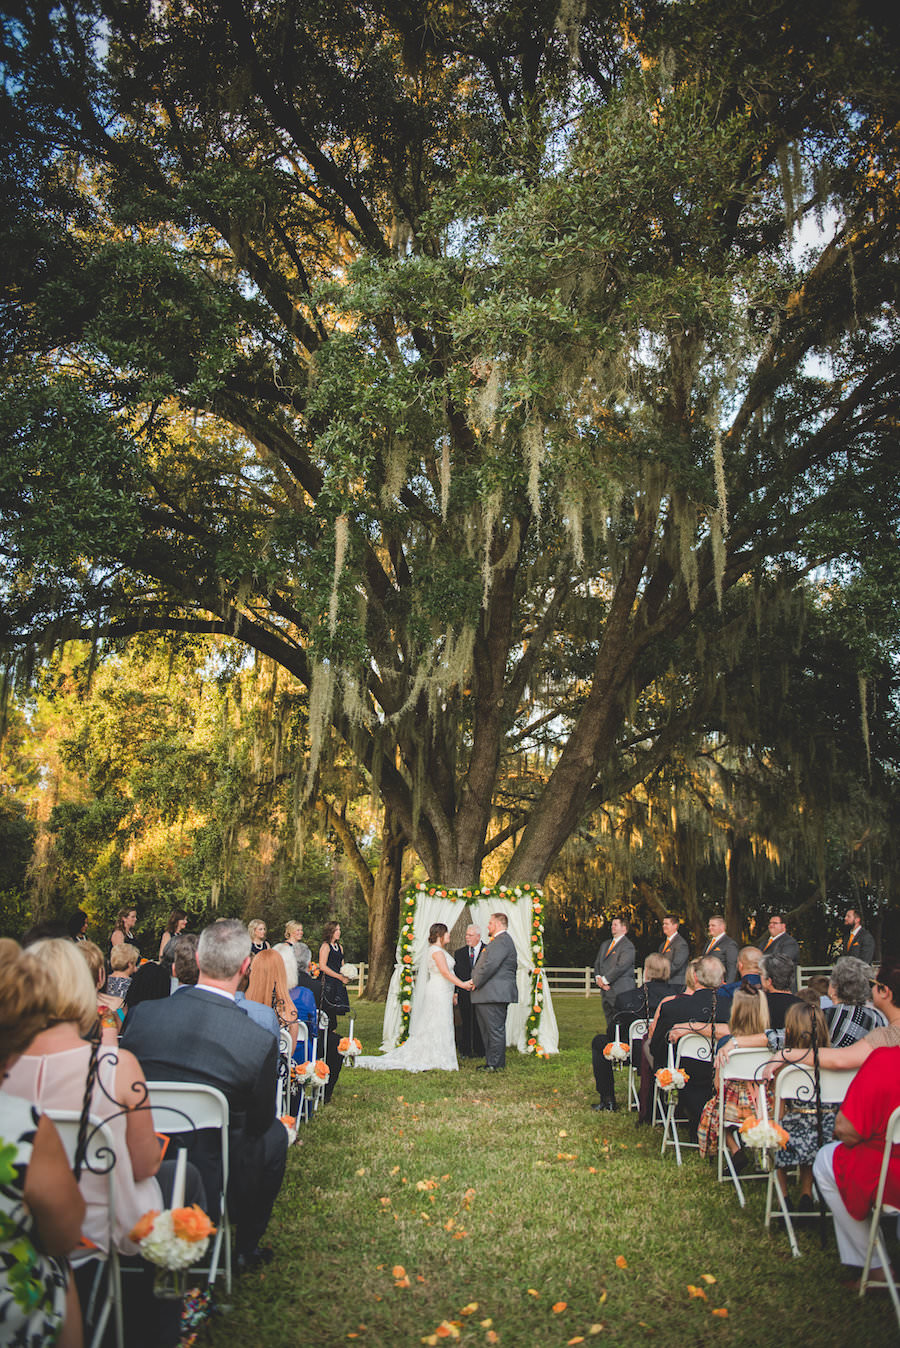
[381,894,559,1053]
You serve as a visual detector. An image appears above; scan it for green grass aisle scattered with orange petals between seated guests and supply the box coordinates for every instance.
[201,998,896,1348]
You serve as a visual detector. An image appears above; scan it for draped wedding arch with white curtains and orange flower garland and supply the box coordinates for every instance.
[381,883,559,1057]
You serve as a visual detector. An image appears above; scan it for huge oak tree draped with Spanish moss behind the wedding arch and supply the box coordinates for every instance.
[0,0,900,981]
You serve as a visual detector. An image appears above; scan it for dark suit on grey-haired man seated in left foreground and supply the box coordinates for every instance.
[121,987,287,1254]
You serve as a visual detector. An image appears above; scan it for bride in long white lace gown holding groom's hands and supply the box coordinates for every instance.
[356,922,472,1072]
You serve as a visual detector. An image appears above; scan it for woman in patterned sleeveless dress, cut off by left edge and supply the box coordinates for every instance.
[0,941,86,1348]
